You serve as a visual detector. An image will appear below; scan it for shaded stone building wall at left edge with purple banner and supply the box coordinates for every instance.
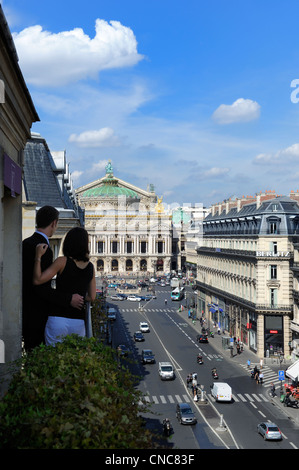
[0,6,39,394]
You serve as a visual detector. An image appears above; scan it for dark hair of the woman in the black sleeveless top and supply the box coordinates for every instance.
[62,227,89,261]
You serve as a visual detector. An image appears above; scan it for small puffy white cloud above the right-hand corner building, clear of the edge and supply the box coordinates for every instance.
[213,98,260,124]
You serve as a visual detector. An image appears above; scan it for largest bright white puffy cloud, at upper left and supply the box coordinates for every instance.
[13,19,143,87]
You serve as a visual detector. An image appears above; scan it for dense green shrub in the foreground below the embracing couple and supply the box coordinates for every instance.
[0,335,153,449]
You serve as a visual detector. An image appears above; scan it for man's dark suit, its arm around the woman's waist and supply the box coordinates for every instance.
[22,233,72,350]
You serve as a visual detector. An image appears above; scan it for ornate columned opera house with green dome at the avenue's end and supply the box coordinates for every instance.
[76,161,172,275]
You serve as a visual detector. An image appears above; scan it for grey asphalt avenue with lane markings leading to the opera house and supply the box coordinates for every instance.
[107,286,299,450]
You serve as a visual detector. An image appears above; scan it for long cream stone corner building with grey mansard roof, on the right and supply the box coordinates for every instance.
[196,191,299,357]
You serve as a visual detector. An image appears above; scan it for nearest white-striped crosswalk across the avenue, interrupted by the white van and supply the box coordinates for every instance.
[139,393,271,405]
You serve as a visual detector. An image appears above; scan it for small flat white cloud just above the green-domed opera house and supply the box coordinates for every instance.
[69,127,120,147]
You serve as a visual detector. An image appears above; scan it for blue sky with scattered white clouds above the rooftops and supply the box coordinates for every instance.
[1,0,299,206]
